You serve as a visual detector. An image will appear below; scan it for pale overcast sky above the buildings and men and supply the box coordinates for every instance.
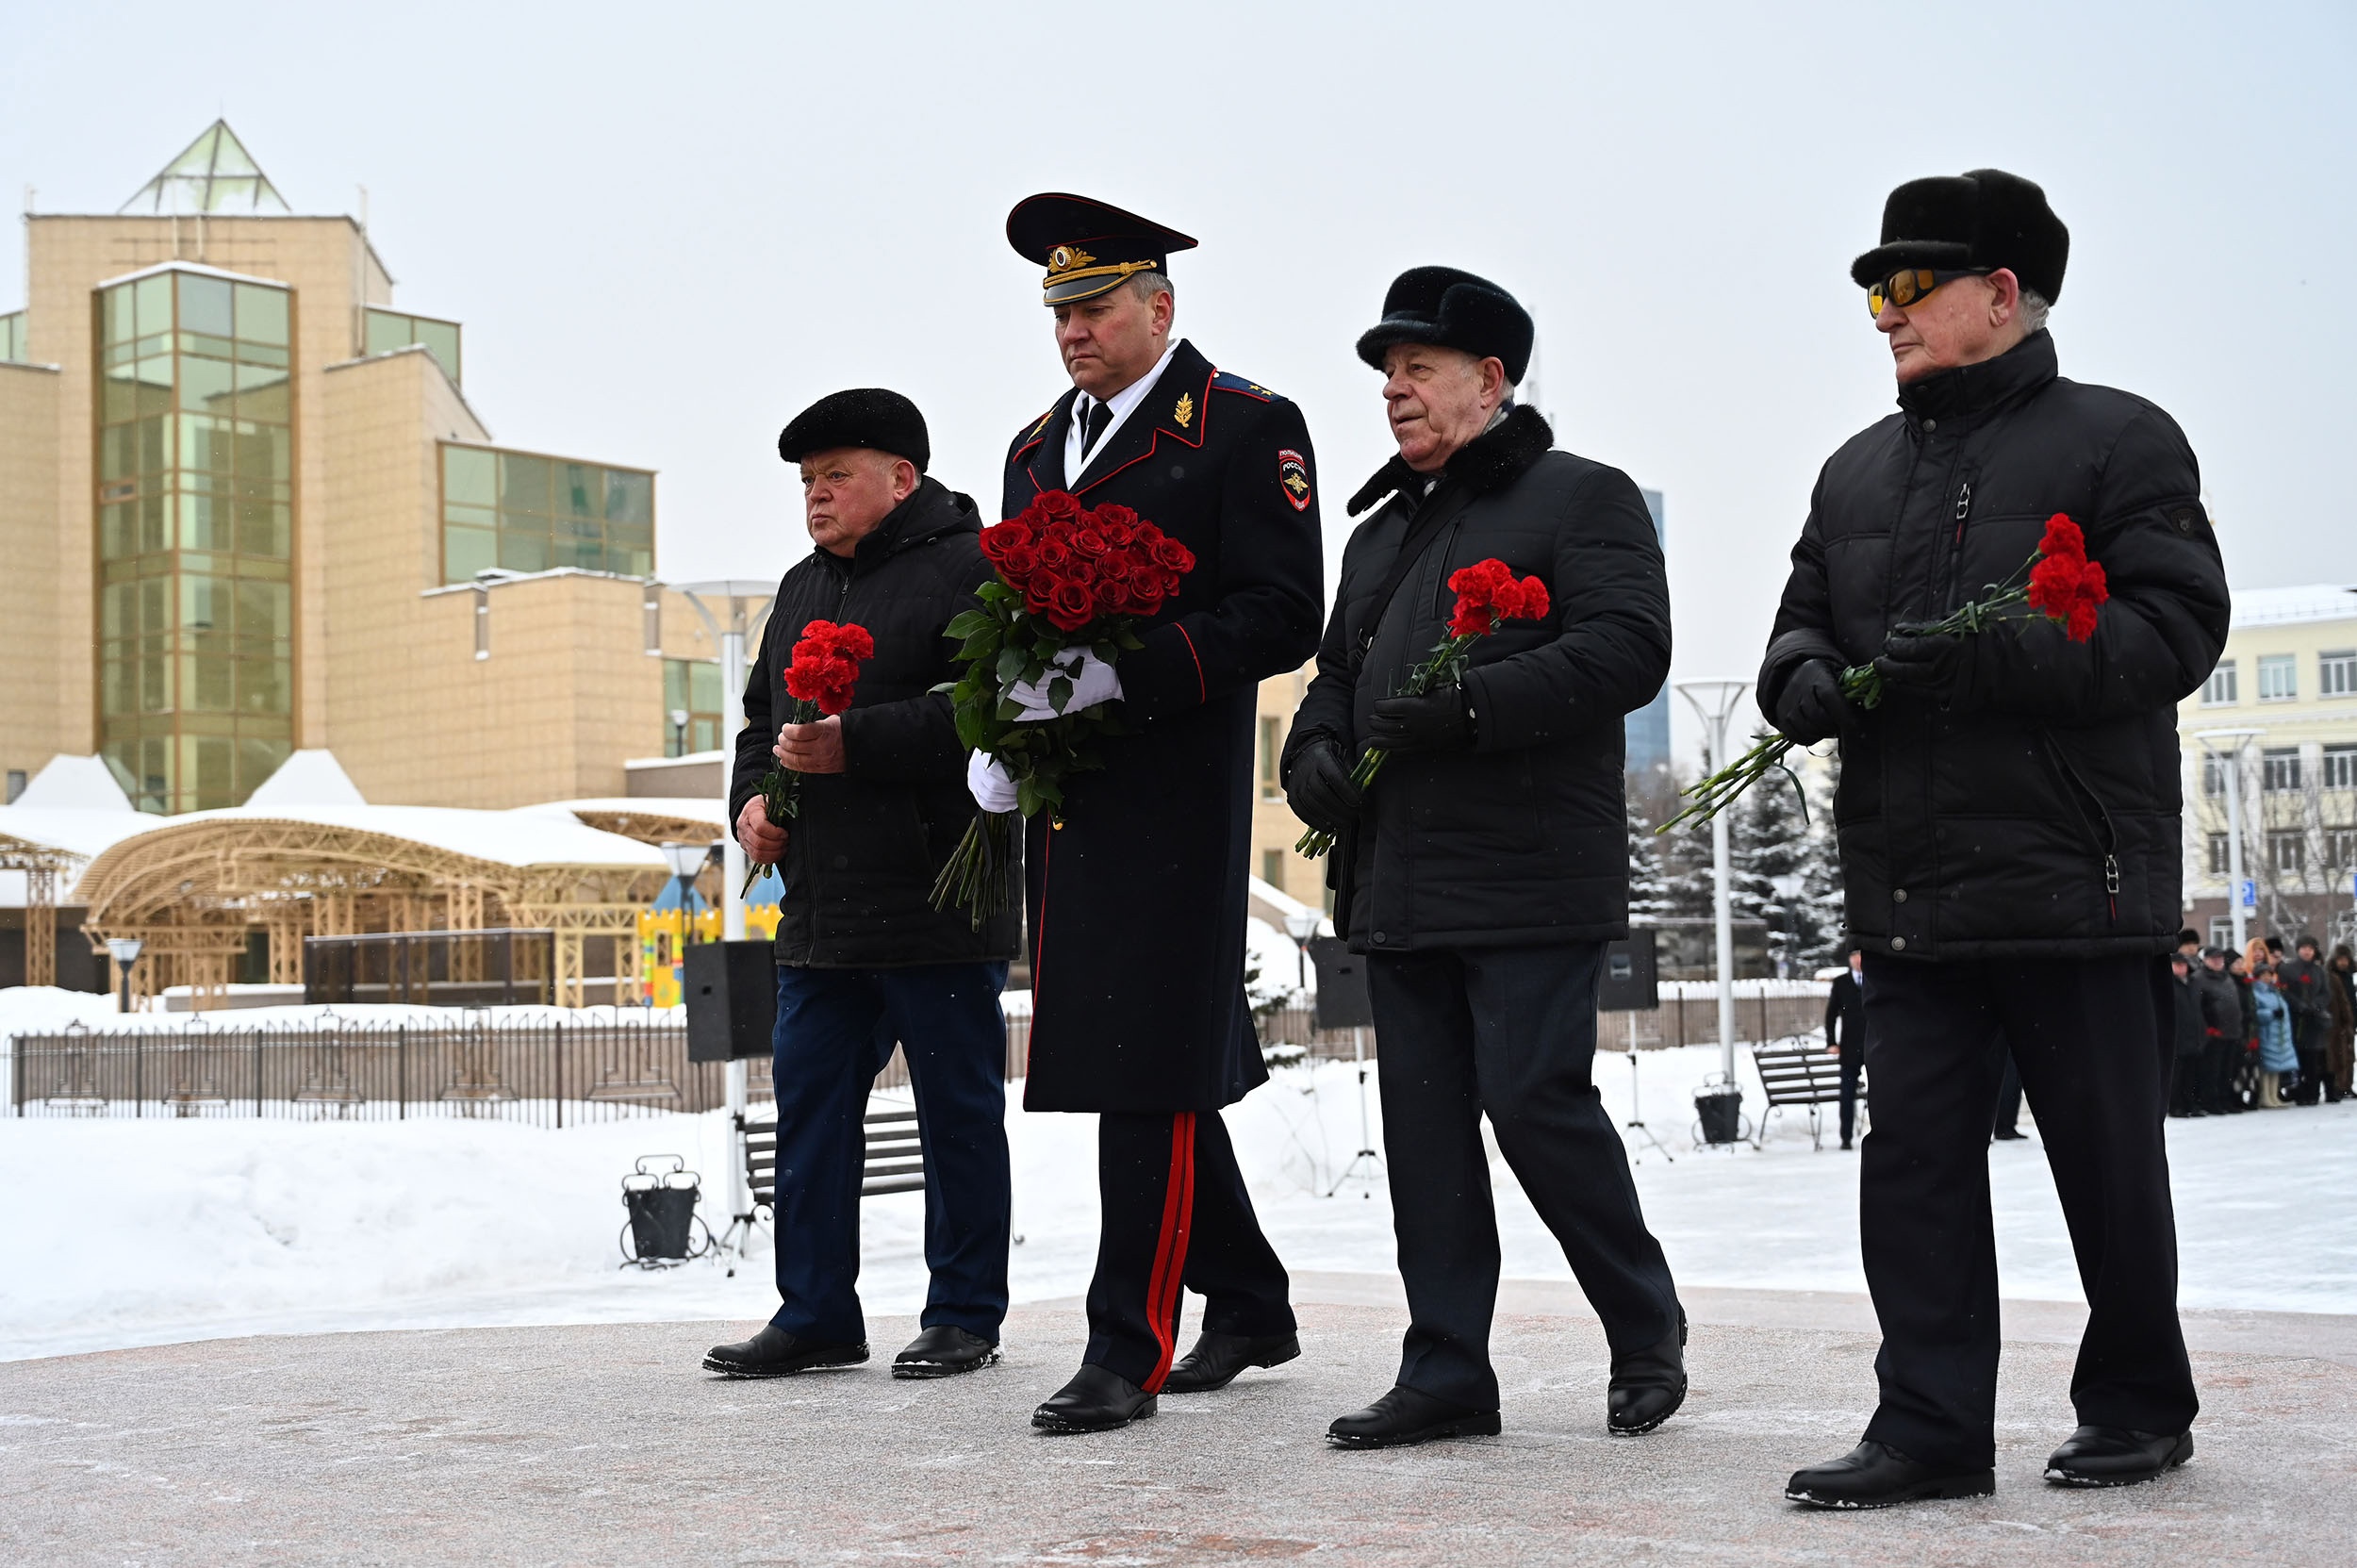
[0,0,2357,759]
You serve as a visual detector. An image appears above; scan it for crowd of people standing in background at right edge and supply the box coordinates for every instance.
[2168,932,2357,1115]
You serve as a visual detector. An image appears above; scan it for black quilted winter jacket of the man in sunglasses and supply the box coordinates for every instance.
[1758,333,2228,960]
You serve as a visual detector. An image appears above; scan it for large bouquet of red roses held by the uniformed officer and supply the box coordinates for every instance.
[933,490,1195,929]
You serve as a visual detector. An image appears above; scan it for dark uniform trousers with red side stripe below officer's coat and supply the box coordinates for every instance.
[1082,1111,1294,1394]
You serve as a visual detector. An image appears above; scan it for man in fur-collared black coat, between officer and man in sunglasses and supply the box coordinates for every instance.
[1285,267,1686,1447]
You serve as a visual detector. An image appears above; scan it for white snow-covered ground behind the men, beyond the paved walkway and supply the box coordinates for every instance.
[0,1028,2357,1358]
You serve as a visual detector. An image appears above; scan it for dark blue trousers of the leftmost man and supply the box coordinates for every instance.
[771,962,1014,1344]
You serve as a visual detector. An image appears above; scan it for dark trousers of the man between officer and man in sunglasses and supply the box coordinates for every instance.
[1367,943,1678,1410]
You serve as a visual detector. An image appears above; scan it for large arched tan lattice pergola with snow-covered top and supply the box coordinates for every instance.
[78,814,669,1007]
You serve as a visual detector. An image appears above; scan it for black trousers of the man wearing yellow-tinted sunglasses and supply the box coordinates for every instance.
[1857,957,2200,1469]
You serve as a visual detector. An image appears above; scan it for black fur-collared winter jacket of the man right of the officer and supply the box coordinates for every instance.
[1285,408,1669,952]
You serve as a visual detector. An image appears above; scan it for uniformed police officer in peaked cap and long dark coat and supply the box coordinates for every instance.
[976,196,1323,1431]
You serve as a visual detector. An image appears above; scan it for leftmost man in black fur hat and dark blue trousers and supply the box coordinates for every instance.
[705,387,1018,1377]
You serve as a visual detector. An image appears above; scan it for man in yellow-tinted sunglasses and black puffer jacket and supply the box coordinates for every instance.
[1758,170,2228,1509]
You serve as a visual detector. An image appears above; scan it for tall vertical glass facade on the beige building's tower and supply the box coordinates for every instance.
[92,269,295,811]
